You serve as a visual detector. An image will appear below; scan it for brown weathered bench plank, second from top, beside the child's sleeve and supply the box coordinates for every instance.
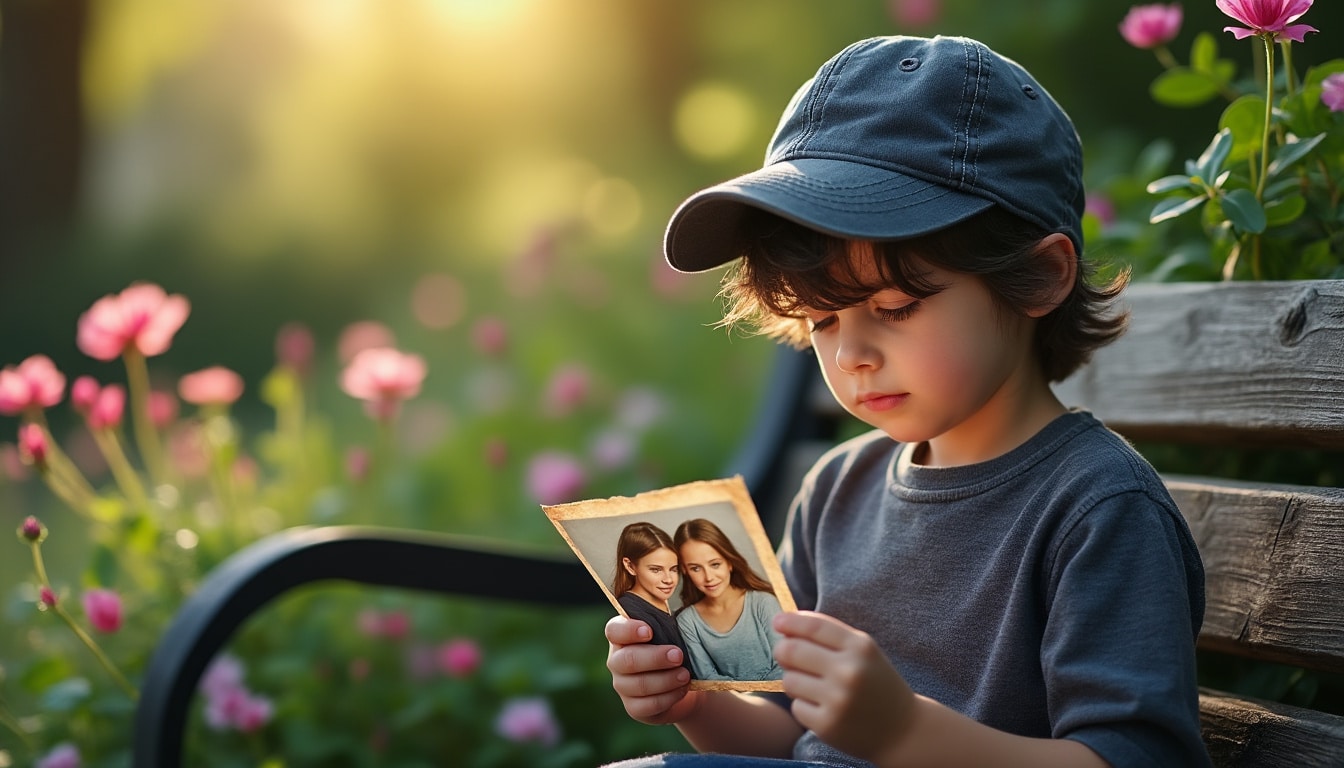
[1165,476,1344,671]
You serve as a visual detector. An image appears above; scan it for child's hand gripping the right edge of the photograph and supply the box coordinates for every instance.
[774,611,915,763]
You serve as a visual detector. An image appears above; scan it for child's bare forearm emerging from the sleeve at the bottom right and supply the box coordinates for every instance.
[875,697,1109,768]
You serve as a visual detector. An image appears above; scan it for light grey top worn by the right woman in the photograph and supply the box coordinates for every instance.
[676,589,784,681]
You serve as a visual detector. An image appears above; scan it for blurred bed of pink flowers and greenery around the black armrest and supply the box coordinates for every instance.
[0,238,769,768]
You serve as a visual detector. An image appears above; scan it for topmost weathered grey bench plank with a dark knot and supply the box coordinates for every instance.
[1056,280,1344,448]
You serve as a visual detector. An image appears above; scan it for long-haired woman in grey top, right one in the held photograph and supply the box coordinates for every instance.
[675,518,784,681]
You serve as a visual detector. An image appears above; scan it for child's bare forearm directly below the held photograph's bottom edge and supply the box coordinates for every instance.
[676,691,802,757]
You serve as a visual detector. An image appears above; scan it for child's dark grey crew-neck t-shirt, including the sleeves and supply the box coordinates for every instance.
[780,412,1208,768]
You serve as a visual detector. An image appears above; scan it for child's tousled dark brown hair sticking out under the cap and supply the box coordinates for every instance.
[720,206,1129,382]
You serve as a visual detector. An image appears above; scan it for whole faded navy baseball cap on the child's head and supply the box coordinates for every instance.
[664,36,1085,272]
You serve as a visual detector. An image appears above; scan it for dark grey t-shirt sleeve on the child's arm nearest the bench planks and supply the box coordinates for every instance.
[1040,491,1208,768]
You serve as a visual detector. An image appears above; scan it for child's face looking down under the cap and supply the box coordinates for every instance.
[806,242,1048,465]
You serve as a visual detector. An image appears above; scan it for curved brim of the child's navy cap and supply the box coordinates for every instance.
[663,157,993,272]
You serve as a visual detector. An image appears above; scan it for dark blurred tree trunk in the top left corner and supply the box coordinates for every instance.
[0,0,89,269]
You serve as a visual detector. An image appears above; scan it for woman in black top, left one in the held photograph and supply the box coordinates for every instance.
[612,523,689,668]
